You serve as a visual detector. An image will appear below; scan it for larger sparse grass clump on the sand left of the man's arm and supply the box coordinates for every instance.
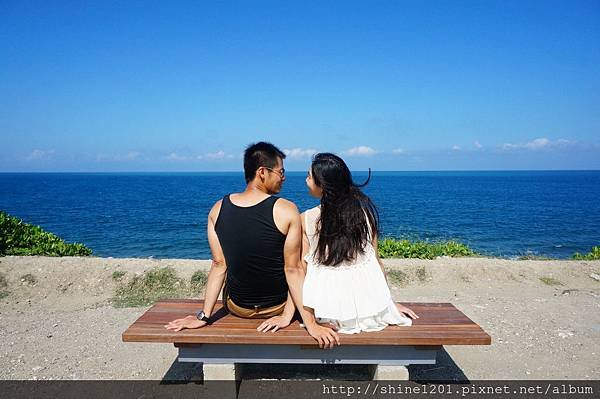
[112,267,187,308]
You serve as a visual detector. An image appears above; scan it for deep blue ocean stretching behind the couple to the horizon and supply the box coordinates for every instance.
[0,171,600,259]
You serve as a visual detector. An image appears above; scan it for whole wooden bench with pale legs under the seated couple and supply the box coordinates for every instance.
[122,300,491,380]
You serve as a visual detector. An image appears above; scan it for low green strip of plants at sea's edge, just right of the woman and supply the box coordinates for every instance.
[378,238,478,259]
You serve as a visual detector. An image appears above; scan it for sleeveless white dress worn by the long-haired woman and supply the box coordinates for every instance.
[302,207,412,334]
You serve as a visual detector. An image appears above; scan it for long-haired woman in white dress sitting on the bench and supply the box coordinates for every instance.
[301,153,418,334]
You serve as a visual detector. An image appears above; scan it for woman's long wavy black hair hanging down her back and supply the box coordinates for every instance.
[311,153,379,266]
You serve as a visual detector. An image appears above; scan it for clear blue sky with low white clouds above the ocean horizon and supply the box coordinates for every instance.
[0,0,600,172]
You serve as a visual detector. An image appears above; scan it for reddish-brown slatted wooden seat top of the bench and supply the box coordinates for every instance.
[122,299,491,346]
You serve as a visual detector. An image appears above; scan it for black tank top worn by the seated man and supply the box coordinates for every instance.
[215,195,288,309]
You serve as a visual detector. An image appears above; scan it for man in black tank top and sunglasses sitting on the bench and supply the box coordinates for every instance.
[165,142,339,347]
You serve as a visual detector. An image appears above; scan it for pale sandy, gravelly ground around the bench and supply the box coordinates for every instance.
[0,257,600,381]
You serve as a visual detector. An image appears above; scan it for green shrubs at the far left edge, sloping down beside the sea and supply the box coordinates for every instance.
[0,211,92,256]
